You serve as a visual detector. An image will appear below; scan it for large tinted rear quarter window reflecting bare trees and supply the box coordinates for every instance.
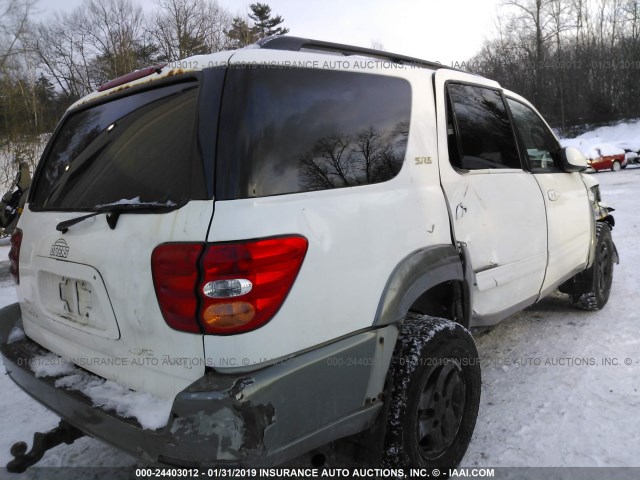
[216,68,411,200]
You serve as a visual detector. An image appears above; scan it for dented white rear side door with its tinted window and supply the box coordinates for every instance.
[435,70,547,324]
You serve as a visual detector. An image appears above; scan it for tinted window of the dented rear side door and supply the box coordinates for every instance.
[448,84,521,170]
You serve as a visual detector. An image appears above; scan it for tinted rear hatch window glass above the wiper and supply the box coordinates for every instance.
[31,81,206,210]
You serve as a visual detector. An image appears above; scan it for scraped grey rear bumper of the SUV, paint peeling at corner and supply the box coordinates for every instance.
[0,304,396,467]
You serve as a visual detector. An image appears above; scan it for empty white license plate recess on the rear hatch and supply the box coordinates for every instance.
[37,258,120,340]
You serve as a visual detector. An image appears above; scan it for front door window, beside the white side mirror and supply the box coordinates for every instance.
[507,99,560,170]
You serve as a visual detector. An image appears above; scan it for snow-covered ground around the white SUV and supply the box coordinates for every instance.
[0,166,640,472]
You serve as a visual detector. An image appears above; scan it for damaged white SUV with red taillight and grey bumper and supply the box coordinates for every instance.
[0,37,617,470]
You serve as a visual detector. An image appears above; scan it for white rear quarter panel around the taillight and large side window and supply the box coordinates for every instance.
[204,50,451,369]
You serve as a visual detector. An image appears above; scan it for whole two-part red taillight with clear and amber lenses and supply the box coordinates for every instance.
[151,236,308,335]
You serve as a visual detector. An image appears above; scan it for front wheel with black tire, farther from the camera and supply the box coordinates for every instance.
[571,222,616,311]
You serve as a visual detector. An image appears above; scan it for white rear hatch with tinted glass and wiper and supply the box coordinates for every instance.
[18,65,224,398]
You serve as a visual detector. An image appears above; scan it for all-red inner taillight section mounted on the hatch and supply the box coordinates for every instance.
[151,243,204,333]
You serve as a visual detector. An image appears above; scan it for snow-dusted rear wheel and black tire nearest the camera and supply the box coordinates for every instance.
[382,314,481,472]
